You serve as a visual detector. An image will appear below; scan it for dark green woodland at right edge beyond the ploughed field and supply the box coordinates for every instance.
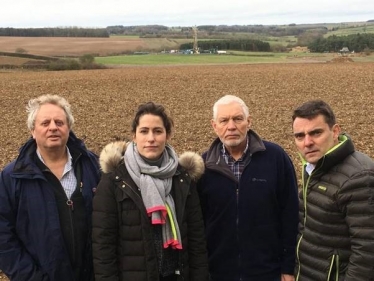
[308,33,374,53]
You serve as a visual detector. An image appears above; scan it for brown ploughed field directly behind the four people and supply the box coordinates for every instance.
[0,60,374,278]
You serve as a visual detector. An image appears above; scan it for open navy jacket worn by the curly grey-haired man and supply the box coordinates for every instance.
[0,132,100,281]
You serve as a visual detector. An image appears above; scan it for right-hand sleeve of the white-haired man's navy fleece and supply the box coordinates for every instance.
[278,154,299,275]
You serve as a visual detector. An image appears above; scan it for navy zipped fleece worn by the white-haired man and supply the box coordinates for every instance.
[198,130,298,281]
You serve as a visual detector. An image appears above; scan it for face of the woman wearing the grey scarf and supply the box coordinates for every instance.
[133,114,169,160]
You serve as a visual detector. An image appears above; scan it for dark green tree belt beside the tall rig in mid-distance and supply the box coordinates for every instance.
[180,39,270,52]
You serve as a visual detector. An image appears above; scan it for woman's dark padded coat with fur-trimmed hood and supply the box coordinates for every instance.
[93,142,208,281]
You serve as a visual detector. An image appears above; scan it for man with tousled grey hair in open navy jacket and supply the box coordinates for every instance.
[0,95,100,281]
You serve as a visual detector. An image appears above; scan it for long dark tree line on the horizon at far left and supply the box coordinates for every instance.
[0,27,109,37]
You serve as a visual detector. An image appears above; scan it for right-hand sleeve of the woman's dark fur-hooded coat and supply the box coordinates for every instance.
[186,182,209,281]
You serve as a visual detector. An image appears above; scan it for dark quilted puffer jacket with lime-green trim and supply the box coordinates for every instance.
[296,134,374,281]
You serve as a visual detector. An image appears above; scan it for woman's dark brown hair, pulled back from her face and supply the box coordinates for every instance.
[131,101,174,135]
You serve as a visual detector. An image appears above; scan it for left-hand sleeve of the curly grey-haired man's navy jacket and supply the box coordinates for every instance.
[0,167,49,281]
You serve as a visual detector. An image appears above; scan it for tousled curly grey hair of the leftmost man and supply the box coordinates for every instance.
[26,94,74,131]
